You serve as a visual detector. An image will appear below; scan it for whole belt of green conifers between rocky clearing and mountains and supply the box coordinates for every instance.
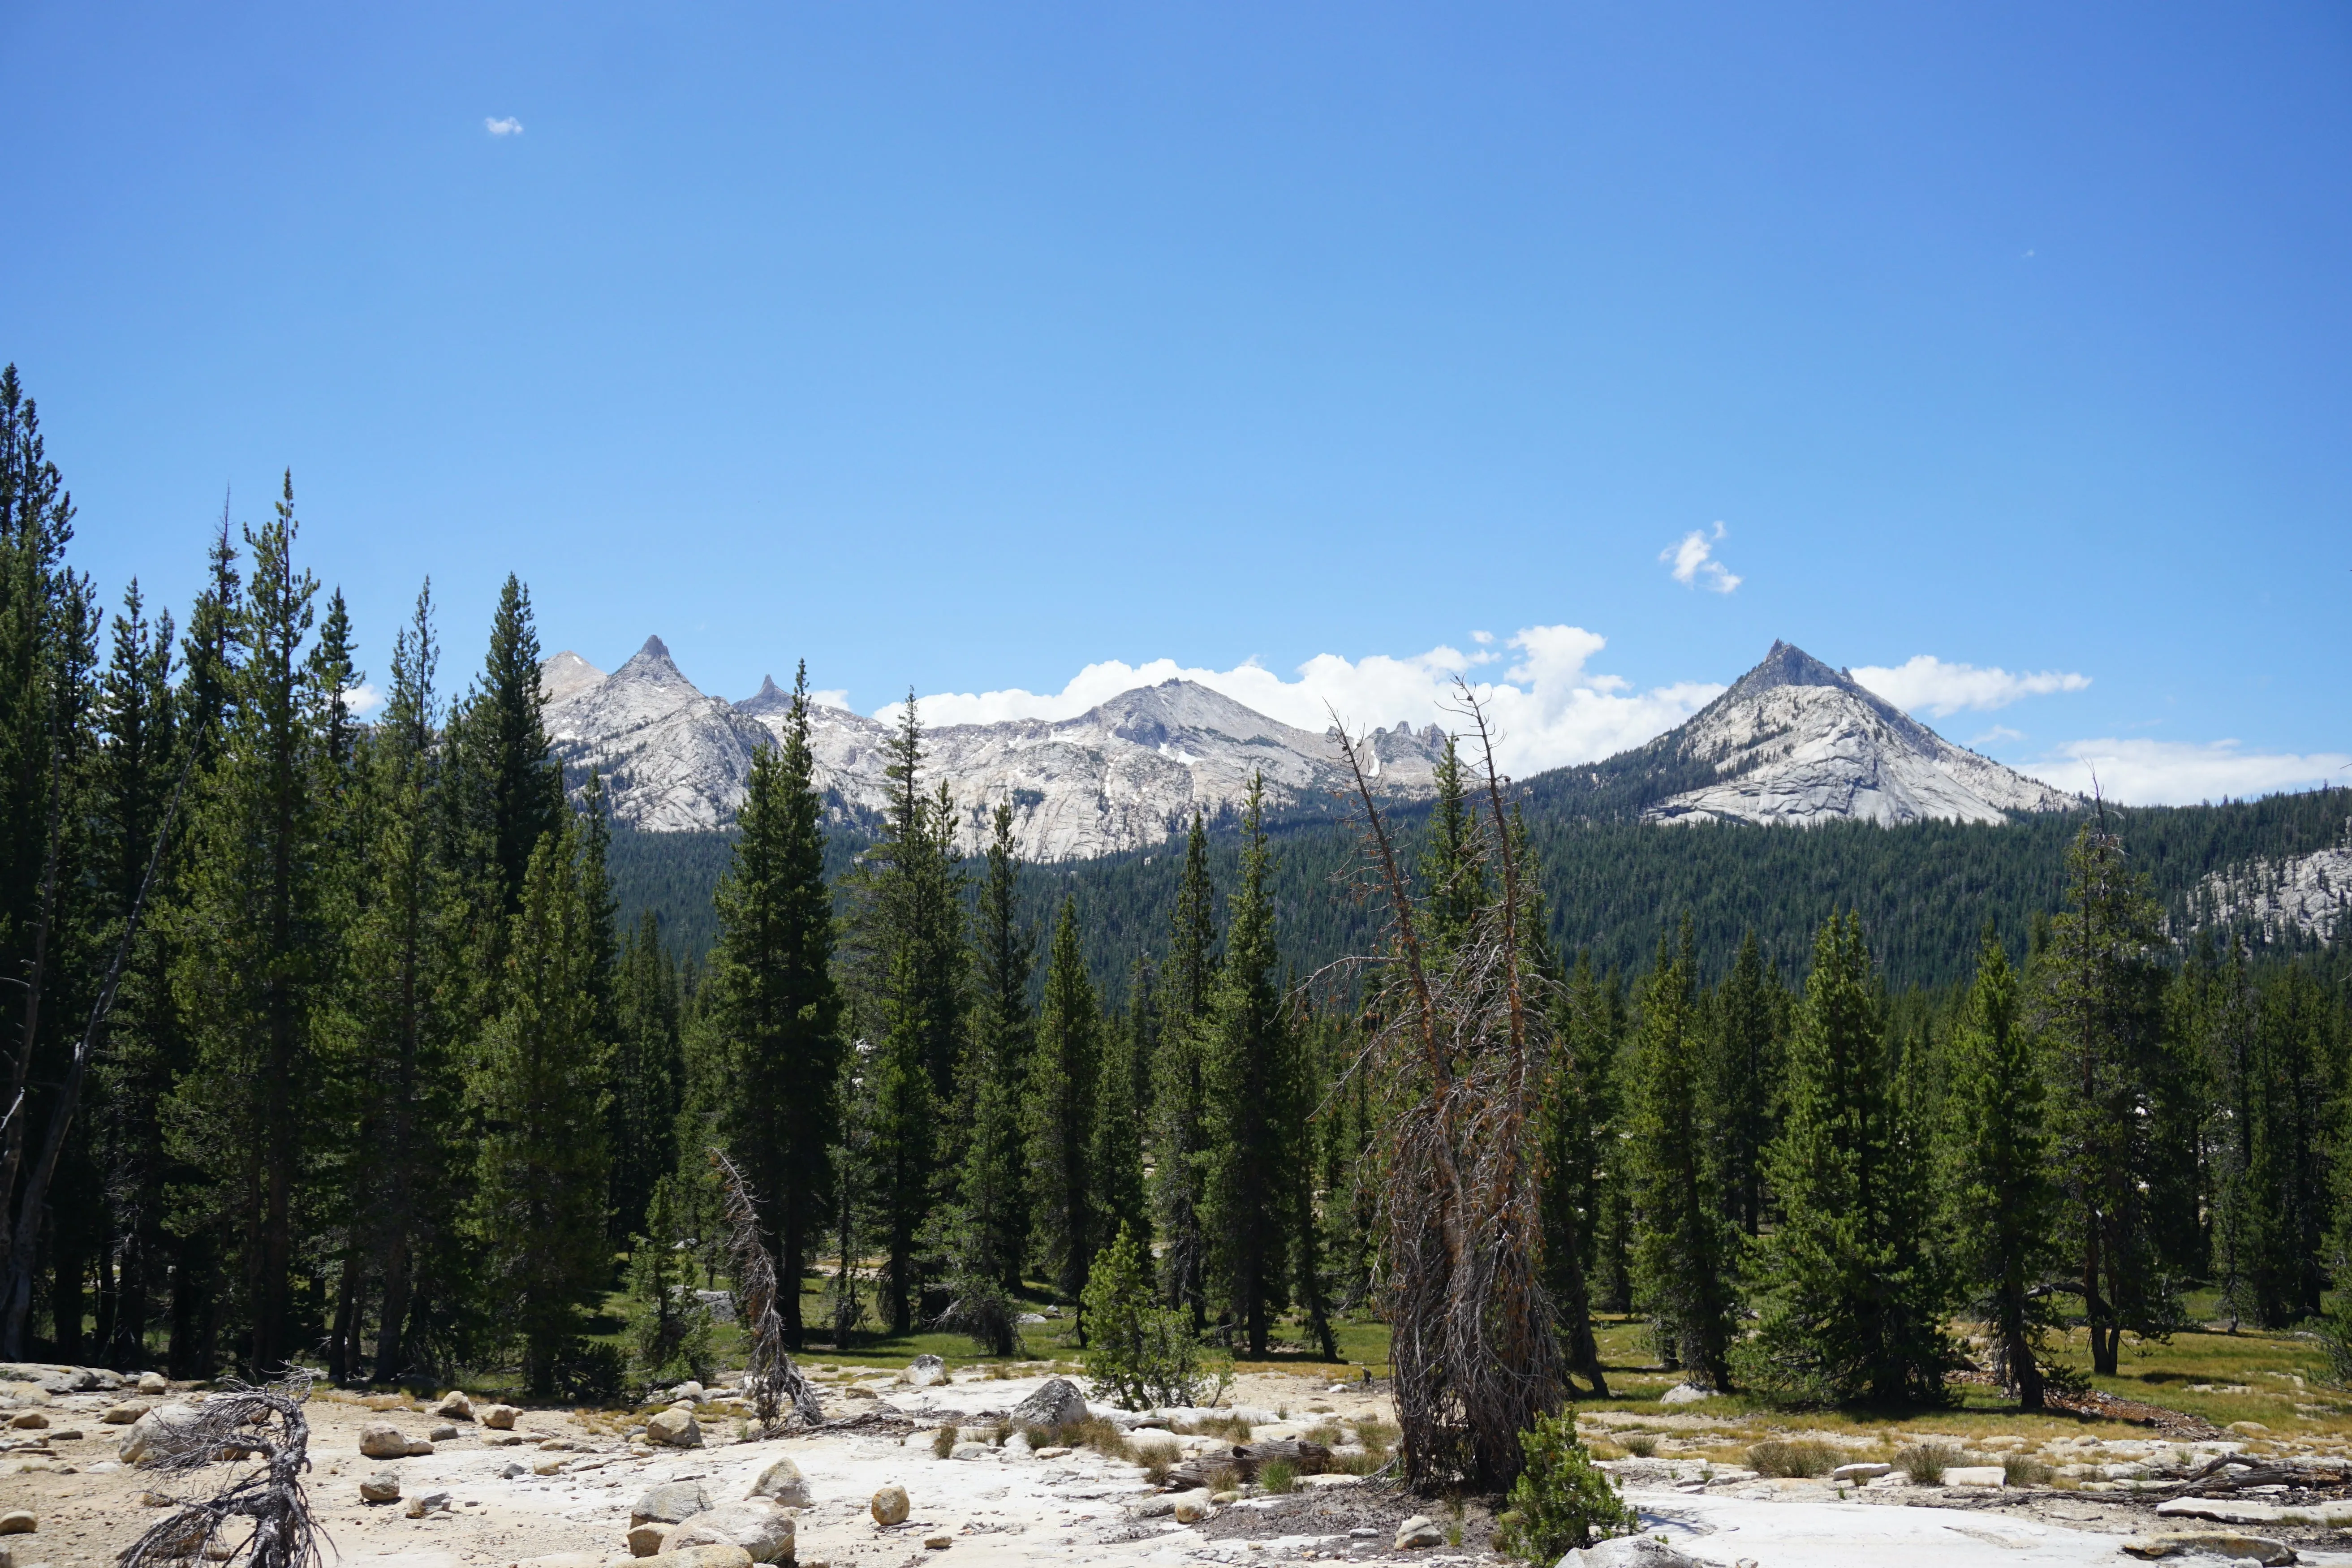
[0,369,2352,1488]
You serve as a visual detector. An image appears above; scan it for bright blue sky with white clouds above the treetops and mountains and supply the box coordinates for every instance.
[0,0,2352,799]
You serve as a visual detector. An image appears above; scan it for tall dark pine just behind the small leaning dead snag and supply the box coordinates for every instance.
[711,665,842,1349]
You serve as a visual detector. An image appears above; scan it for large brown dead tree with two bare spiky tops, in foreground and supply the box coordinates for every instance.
[1338,686,1569,1490]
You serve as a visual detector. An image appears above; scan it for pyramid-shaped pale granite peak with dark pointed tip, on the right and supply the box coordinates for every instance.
[1642,642,2084,825]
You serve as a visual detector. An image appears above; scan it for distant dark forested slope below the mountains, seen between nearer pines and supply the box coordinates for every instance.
[612,773,2352,987]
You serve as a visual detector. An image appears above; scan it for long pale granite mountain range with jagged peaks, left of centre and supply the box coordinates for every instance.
[541,637,1444,861]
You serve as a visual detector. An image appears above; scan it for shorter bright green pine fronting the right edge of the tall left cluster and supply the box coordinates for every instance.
[468,823,609,1396]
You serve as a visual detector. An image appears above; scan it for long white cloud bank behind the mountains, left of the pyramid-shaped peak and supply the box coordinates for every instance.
[875,625,1722,773]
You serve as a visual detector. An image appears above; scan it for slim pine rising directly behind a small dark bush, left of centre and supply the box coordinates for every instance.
[955,801,1037,1291]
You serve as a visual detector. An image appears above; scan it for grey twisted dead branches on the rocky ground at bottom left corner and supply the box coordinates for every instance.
[115,1373,322,1568]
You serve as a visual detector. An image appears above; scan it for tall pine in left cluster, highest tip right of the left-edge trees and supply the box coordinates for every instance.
[161,475,334,1373]
